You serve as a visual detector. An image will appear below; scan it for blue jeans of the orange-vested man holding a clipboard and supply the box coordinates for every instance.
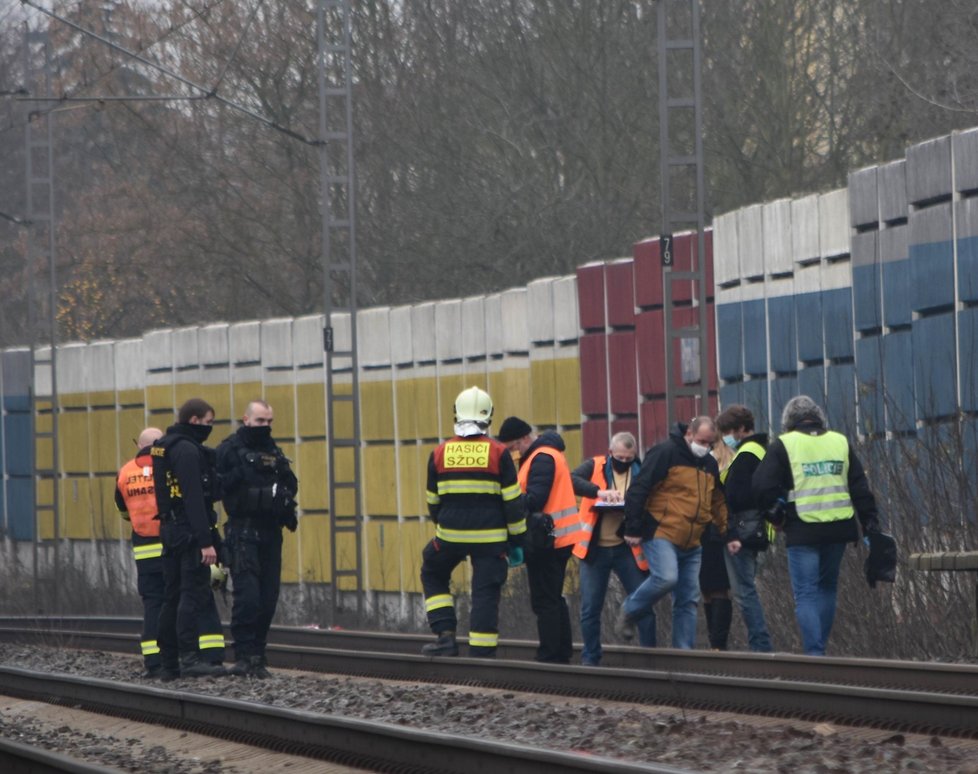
[579,543,655,666]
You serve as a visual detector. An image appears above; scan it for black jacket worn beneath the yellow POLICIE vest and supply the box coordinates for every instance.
[751,424,879,546]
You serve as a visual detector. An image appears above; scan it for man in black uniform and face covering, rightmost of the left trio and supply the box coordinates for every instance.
[217,400,299,678]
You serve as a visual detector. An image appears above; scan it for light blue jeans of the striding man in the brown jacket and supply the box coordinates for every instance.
[622,538,703,650]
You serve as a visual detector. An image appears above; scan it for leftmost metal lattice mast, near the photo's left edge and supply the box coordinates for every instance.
[24,24,61,612]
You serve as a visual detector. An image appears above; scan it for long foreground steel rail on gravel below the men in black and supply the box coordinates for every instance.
[0,667,688,774]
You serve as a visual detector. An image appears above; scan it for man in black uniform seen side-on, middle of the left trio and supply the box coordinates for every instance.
[150,398,226,680]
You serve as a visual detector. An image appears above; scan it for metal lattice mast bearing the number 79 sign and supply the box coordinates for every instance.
[658,0,710,426]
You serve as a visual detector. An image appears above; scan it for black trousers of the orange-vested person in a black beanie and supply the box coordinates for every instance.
[526,546,574,664]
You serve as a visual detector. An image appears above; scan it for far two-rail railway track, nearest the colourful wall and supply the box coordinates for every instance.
[0,618,978,738]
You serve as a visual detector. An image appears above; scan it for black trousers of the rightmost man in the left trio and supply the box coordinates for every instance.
[225,521,282,659]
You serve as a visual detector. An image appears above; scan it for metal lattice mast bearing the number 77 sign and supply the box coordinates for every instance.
[316,0,363,616]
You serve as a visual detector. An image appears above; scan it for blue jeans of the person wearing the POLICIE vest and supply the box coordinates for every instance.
[788,543,846,656]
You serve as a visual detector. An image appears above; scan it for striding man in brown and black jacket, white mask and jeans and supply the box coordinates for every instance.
[615,417,740,650]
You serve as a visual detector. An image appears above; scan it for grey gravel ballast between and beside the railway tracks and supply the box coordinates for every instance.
[0,645,978,774]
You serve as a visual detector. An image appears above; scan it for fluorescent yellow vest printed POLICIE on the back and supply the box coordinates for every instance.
[781,430,854,522]
